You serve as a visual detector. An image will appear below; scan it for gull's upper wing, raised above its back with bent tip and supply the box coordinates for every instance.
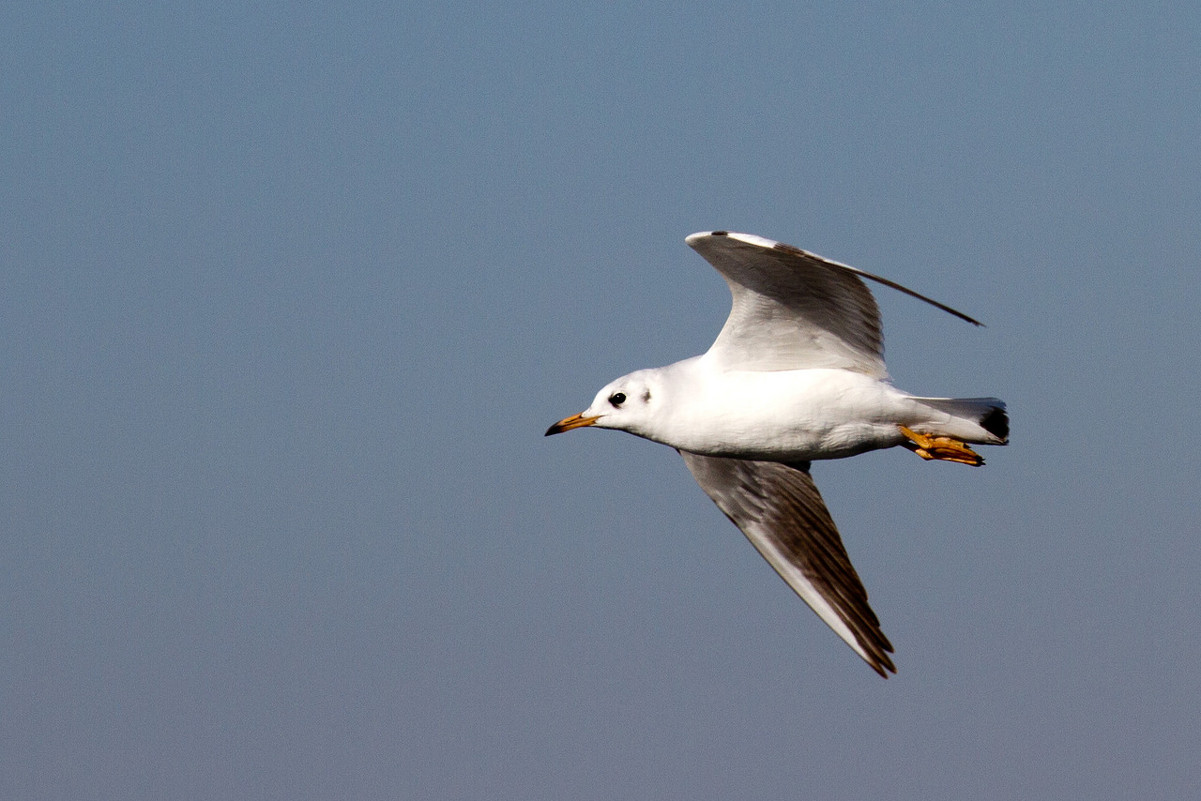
[686,231,980,378]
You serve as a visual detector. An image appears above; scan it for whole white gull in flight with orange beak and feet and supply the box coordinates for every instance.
[545,231,1009,679]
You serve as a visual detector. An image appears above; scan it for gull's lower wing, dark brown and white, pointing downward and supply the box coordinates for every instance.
[680,450,896,679]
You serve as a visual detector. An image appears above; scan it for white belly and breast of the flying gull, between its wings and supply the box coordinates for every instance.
[662,370,908,461]
